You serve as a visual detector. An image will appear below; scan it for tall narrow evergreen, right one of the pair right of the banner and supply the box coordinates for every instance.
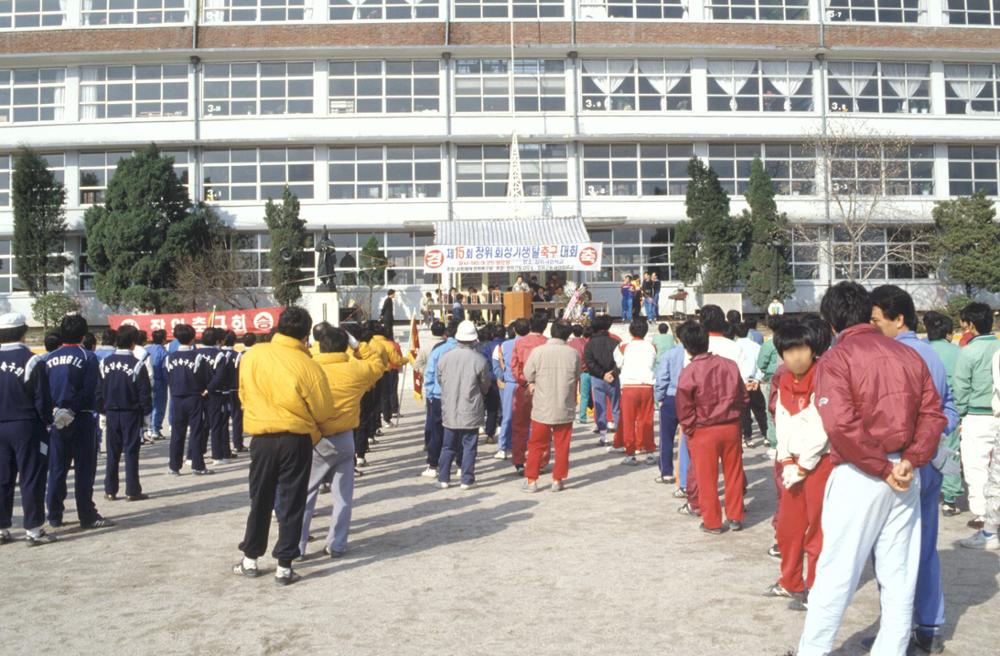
[743,157,795,309]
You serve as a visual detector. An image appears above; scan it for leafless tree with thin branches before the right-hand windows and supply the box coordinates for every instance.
[793,119,933,282]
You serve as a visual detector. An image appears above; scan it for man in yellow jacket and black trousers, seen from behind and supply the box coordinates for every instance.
[233,307,338,585]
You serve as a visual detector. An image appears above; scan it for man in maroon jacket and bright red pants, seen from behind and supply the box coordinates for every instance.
[676,321,750,534]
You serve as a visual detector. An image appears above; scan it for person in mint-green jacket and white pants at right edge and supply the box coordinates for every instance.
[952,303,1000,530]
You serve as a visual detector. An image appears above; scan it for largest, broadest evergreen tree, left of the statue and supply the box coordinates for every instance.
[84,144,222,312]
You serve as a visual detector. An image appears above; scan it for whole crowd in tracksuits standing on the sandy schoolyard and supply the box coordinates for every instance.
[0,282,1000,655]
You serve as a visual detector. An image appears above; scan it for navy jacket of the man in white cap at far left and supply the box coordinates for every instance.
[0,343,52,425]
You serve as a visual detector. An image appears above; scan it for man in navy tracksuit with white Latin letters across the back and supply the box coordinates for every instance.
[45,314,114,528]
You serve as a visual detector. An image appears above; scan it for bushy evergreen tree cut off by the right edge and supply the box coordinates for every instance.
[931,191,1000,297]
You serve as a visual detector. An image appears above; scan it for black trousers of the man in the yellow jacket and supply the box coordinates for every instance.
[240,433,312,567]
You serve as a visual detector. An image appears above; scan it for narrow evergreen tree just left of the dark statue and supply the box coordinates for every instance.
[264,186,309,307]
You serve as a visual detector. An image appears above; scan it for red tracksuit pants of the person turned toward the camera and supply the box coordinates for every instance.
[778,456,833,592]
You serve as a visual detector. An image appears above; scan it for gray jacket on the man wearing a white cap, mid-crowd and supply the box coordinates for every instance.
[437,342,493,430]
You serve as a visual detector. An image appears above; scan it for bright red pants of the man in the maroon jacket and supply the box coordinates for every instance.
[688,421,745,528]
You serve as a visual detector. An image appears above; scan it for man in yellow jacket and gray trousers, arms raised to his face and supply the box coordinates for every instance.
[299,324,385,558]
